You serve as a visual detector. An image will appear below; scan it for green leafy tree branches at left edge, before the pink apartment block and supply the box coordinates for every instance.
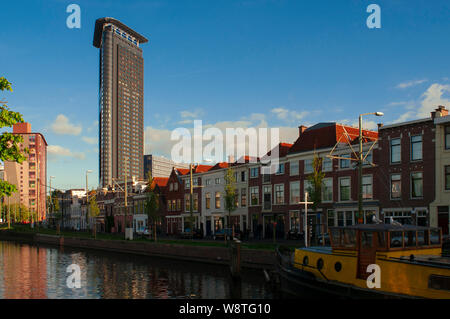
[0,77,28,228]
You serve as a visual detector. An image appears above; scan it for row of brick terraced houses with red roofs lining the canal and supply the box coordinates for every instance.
[72,106,450,238]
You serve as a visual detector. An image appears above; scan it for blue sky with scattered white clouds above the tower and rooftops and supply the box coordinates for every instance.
[0,0,450,189]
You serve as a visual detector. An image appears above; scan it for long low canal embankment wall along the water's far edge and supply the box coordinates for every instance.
[0,231,276,269]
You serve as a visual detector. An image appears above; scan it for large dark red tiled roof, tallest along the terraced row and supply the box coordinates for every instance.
[288,122,378,154]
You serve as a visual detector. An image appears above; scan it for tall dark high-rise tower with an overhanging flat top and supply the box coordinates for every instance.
[93,18,148,187]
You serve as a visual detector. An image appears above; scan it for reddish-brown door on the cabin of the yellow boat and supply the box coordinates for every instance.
[357,231,376,279]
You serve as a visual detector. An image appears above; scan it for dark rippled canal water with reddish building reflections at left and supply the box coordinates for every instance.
[0,241,277,299]
